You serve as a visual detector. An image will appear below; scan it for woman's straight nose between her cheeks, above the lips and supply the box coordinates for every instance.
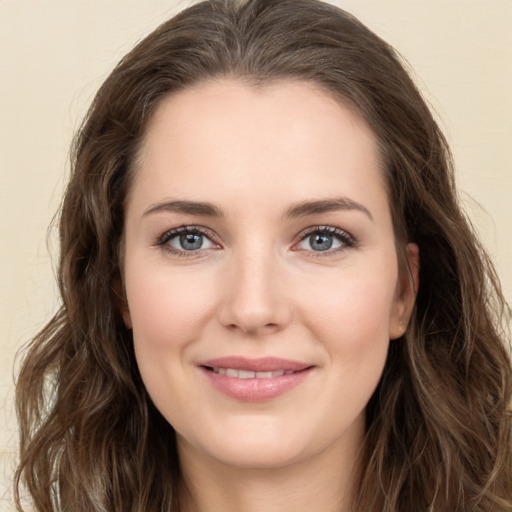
[218,248,292,336]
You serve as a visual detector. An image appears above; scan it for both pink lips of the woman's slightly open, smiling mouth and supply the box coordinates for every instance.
[199,356,313,402]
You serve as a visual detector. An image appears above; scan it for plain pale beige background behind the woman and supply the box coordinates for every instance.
[0,0,512,511]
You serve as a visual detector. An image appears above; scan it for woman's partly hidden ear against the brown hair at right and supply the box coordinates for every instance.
[389,244,420,340]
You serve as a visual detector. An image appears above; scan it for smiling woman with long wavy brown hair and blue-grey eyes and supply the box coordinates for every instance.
[16,0,512,512]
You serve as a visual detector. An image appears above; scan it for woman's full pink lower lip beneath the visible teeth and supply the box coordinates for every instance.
[201,367,312,402]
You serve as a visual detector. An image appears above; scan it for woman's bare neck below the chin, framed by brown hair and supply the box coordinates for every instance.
[180,432,361,512]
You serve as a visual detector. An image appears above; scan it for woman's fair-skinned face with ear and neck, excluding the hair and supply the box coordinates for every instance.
[123,79,418,512]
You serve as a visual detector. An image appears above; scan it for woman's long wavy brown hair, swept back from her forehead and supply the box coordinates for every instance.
[15,0,512,512]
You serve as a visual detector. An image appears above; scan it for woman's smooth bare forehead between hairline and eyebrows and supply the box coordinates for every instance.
[127,79,385,219]
